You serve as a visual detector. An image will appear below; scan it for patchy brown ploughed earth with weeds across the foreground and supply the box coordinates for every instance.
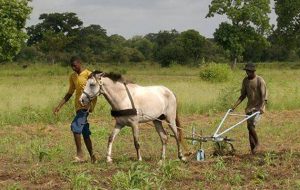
[0,110,300,189]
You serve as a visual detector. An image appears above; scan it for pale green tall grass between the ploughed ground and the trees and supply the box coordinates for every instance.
[0,63,300,126]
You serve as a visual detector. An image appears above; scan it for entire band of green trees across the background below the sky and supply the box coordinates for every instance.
[0,0,300,66]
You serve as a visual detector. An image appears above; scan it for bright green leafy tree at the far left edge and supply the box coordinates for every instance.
[0,0,31,61]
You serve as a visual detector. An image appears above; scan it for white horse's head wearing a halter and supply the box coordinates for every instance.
[79,71,104,105]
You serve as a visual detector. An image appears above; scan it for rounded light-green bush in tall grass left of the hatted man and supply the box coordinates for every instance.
[200,64,232,82]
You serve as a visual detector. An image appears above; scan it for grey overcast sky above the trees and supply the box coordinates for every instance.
[27,0,276,38]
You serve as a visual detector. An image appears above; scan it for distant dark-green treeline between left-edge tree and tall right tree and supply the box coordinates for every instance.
[16,13,226,66]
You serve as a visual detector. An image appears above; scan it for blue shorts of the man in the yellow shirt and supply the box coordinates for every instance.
[71,109,91,137]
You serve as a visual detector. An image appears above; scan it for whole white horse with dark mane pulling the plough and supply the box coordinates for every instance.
[80,71,185,162]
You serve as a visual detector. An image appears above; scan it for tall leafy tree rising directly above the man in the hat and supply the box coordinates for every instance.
[206,0,271,64]
